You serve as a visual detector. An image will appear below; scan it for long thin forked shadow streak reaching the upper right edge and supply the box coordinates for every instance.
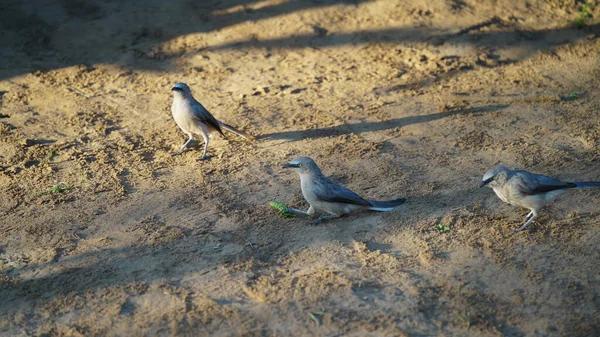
[207,17,600,92]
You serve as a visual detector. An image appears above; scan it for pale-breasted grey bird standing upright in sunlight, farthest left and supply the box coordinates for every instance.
[171,83,254,160]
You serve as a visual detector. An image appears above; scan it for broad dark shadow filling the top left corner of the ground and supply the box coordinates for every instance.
[0,0,368,79]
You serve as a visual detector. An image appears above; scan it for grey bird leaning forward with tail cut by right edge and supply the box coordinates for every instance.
[479,165,600,232]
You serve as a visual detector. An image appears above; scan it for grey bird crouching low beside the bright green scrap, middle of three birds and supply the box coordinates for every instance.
[283,157,406,224]
